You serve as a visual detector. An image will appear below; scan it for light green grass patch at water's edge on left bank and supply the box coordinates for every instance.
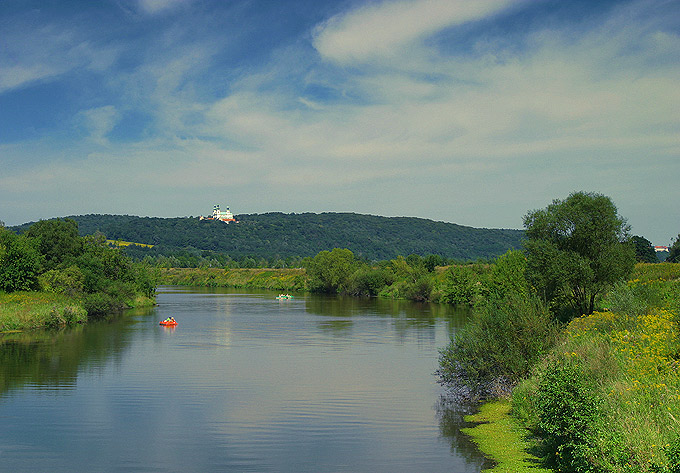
[0,291,87,332]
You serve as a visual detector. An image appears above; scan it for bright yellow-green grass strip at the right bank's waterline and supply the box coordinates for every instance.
[462,401,552,473]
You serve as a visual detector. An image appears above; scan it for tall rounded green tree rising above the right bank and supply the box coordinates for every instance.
[524,192,635,315]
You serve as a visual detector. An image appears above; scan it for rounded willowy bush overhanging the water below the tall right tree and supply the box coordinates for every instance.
[438,293,557,397]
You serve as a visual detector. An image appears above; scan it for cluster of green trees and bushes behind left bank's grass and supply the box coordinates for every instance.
[0,219,156,318]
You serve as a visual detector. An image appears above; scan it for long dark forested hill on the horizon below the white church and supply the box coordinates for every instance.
[15,212,524,260]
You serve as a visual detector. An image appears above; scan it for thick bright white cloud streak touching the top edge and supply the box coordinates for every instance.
[314,0,517,64]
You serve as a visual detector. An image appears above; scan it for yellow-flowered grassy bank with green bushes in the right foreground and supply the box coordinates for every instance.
[513,263,680,473]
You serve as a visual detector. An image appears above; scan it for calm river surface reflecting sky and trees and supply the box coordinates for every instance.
[0,287,484,473]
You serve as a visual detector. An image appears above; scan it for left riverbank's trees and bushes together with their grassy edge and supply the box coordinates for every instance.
[0,219,156,332]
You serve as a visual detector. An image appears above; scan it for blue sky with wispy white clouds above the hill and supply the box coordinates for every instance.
[0,0,680,245]
